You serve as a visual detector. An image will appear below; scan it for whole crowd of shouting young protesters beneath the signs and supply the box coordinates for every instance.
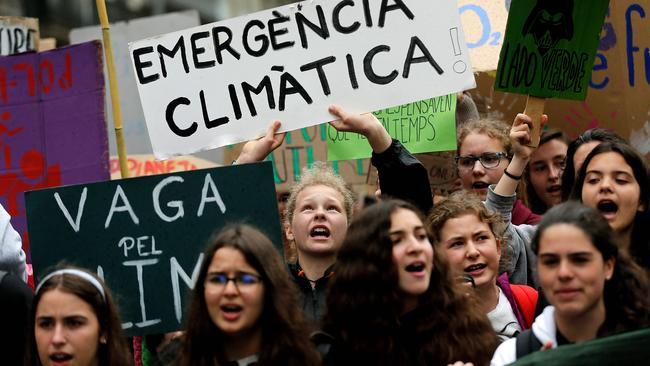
[0,89,650,366]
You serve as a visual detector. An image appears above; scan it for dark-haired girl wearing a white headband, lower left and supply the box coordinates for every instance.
[25,266,133,366]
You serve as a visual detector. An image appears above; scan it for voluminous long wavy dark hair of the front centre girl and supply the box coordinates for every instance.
[323,200,497,365]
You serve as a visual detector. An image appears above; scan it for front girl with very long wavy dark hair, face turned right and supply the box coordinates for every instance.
[315,200,497,365]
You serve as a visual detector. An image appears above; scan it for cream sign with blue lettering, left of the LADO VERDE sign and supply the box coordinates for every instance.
[458,0,509,71]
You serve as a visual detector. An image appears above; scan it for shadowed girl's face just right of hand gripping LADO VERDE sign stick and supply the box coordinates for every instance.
[524,130,568,215]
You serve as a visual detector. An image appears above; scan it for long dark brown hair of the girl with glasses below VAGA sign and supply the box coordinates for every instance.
[180,225,320,366]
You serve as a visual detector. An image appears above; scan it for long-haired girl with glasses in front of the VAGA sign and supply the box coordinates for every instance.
[180,225,319,366]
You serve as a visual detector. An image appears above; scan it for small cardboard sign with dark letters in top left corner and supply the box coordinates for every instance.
[0,16,39,56]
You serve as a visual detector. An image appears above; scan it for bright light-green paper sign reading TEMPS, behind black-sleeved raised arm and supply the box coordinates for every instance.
[327,93,456,161]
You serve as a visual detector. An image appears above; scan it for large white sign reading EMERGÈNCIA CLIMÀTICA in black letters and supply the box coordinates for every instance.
[129,0,475,159]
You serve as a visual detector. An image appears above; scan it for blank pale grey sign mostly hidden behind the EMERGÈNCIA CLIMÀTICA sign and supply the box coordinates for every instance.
[70,10,200,157]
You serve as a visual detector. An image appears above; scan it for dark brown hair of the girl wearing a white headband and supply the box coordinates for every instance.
[25,264,133,366]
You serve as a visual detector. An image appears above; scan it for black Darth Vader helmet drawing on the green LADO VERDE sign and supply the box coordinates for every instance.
[522,0,573,57]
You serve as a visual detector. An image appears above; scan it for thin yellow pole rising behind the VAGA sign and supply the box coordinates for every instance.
[96,0,129,178]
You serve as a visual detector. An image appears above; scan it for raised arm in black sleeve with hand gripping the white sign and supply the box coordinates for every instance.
[329,105,433,215]
